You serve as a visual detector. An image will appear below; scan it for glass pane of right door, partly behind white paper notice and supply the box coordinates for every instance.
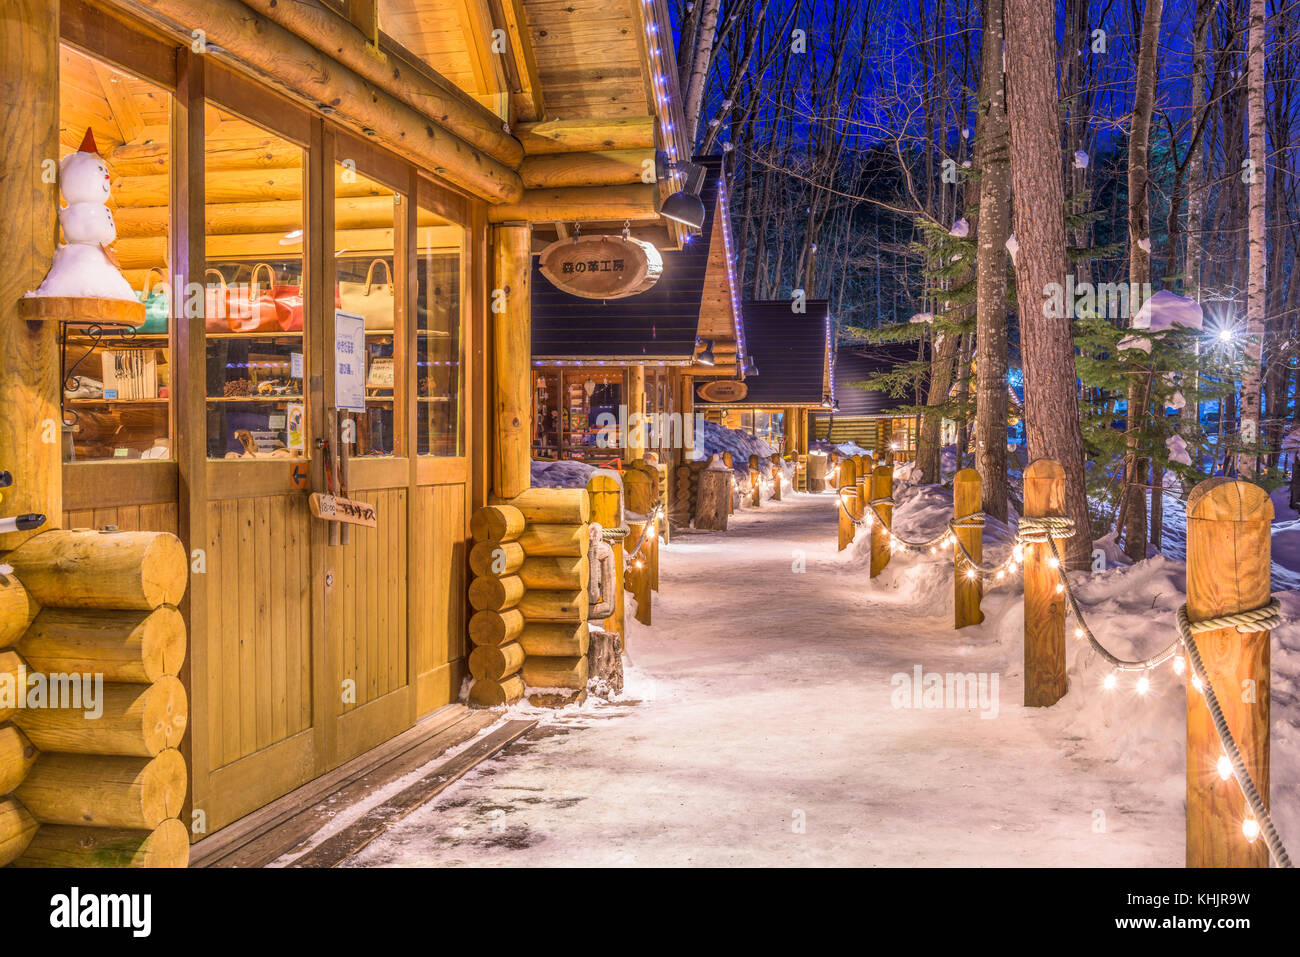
[334,161,406,456]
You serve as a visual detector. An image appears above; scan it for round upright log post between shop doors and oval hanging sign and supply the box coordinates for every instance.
[489,222,533,499]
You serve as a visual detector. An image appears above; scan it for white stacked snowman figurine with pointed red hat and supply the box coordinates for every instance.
[27,129,137,302]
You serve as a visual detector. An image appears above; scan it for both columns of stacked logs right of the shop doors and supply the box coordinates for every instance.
[469,489,590,707]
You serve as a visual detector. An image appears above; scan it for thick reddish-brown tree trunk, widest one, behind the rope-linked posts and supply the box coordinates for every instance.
[1005,0,1092,568]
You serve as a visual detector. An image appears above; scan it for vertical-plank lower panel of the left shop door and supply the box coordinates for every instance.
[207,494,312,767]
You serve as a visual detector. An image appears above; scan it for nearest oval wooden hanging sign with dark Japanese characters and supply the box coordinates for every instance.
[537,235,663,299]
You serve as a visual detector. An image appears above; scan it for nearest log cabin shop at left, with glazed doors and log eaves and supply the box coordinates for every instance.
[0,0,702,863]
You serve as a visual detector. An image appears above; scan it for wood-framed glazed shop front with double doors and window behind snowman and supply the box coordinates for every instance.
[52,16,485,840]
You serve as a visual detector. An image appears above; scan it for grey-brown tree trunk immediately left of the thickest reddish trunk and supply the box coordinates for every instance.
[975,0,1011,521]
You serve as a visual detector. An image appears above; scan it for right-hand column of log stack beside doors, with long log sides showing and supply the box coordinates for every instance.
[512,486,592,707]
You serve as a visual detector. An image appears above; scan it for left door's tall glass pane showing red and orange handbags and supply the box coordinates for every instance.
[204,104,308,459]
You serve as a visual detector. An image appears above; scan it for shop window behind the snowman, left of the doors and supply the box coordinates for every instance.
[59,46,173,462]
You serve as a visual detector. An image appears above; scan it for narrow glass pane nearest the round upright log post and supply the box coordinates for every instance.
[416,207,465,455]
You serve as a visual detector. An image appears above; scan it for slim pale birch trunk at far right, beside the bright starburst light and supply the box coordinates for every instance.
[1236,0,1268,479]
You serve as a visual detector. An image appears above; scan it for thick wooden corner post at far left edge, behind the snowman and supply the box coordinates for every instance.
[0,0,64,553]
